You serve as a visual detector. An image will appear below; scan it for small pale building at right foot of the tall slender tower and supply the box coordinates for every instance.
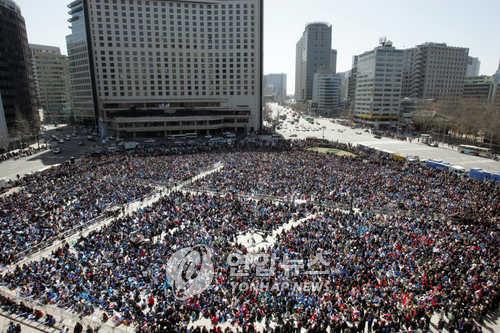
[312,71,342,117]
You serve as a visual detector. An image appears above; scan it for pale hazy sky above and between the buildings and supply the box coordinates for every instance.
[15,0,500,92]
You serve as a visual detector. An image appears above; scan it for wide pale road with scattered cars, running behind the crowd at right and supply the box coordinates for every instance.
[270,104,500,173]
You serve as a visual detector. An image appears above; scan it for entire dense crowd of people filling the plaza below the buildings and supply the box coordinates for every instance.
[0,142,500,333]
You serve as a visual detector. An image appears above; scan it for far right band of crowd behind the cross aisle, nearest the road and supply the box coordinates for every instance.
[192,148,500,219]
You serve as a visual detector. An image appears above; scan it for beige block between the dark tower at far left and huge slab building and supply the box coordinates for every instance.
[29,44,71,123]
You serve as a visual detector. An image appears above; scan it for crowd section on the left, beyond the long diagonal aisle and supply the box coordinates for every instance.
[0,155,218,266]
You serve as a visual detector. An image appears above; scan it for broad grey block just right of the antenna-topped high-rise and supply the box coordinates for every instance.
[410,43,469,99]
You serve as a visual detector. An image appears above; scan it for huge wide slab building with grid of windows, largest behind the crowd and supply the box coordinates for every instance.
[68,0,263,137]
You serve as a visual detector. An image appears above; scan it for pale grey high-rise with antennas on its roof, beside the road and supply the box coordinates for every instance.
[353,39,404,128]
